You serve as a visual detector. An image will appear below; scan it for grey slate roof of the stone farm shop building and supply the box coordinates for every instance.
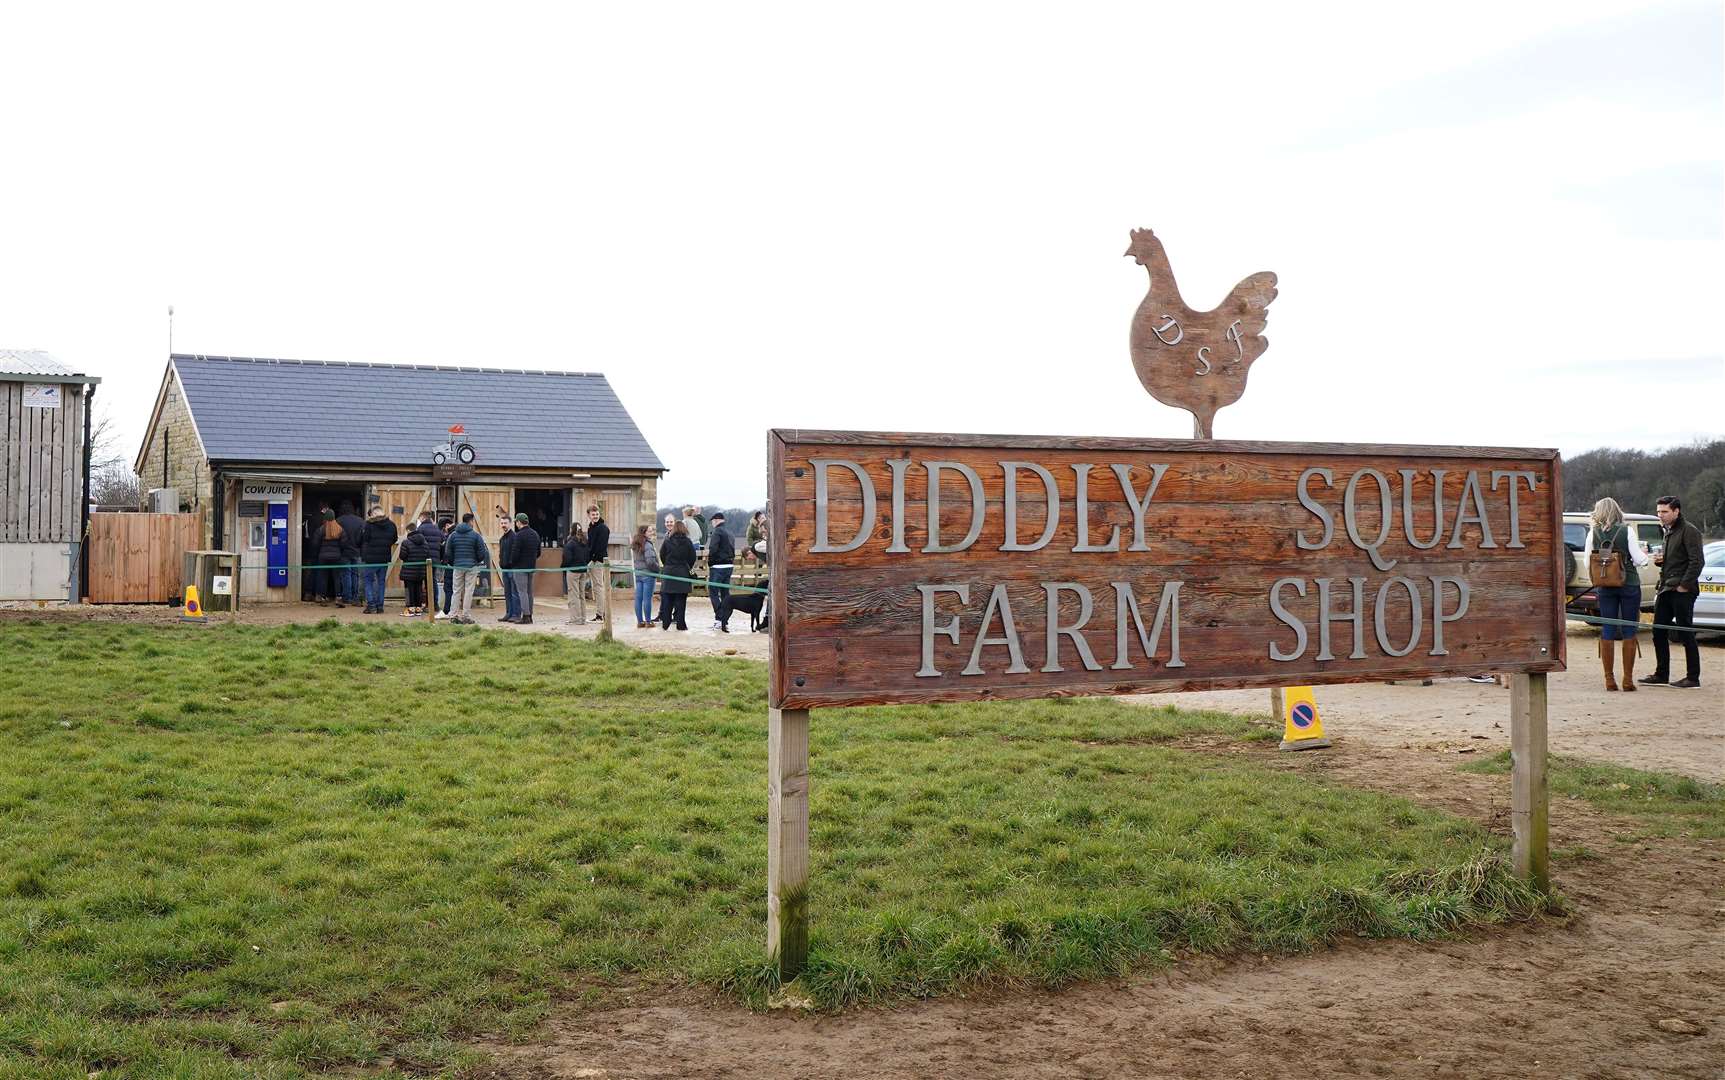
[171,354,664,469]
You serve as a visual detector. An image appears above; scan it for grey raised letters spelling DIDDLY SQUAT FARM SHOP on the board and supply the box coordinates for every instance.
[809,457,1539,678]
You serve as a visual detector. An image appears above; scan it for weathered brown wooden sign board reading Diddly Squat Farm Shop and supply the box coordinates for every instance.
[768,430,1565,709]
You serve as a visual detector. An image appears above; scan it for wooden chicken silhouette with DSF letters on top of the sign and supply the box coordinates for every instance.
[1126,229,1277,438]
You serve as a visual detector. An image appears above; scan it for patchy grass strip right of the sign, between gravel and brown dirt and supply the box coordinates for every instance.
[1461,750,1725,840]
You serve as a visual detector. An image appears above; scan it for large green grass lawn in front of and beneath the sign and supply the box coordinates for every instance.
[0,621,1542,1080]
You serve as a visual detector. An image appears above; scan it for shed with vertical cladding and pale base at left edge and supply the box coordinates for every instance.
[0,348,102,600]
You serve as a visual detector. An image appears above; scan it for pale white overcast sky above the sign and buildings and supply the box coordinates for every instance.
[0,0,1725,505]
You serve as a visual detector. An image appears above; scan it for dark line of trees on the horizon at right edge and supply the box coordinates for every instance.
[1563,438,1725,540]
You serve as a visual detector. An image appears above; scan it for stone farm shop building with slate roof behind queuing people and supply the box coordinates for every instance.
[136,354,664,600]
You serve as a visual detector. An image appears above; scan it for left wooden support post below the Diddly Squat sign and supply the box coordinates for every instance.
[766,709,809,983]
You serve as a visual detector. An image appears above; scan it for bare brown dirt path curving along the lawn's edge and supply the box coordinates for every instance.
[486,744,1725,1080]
